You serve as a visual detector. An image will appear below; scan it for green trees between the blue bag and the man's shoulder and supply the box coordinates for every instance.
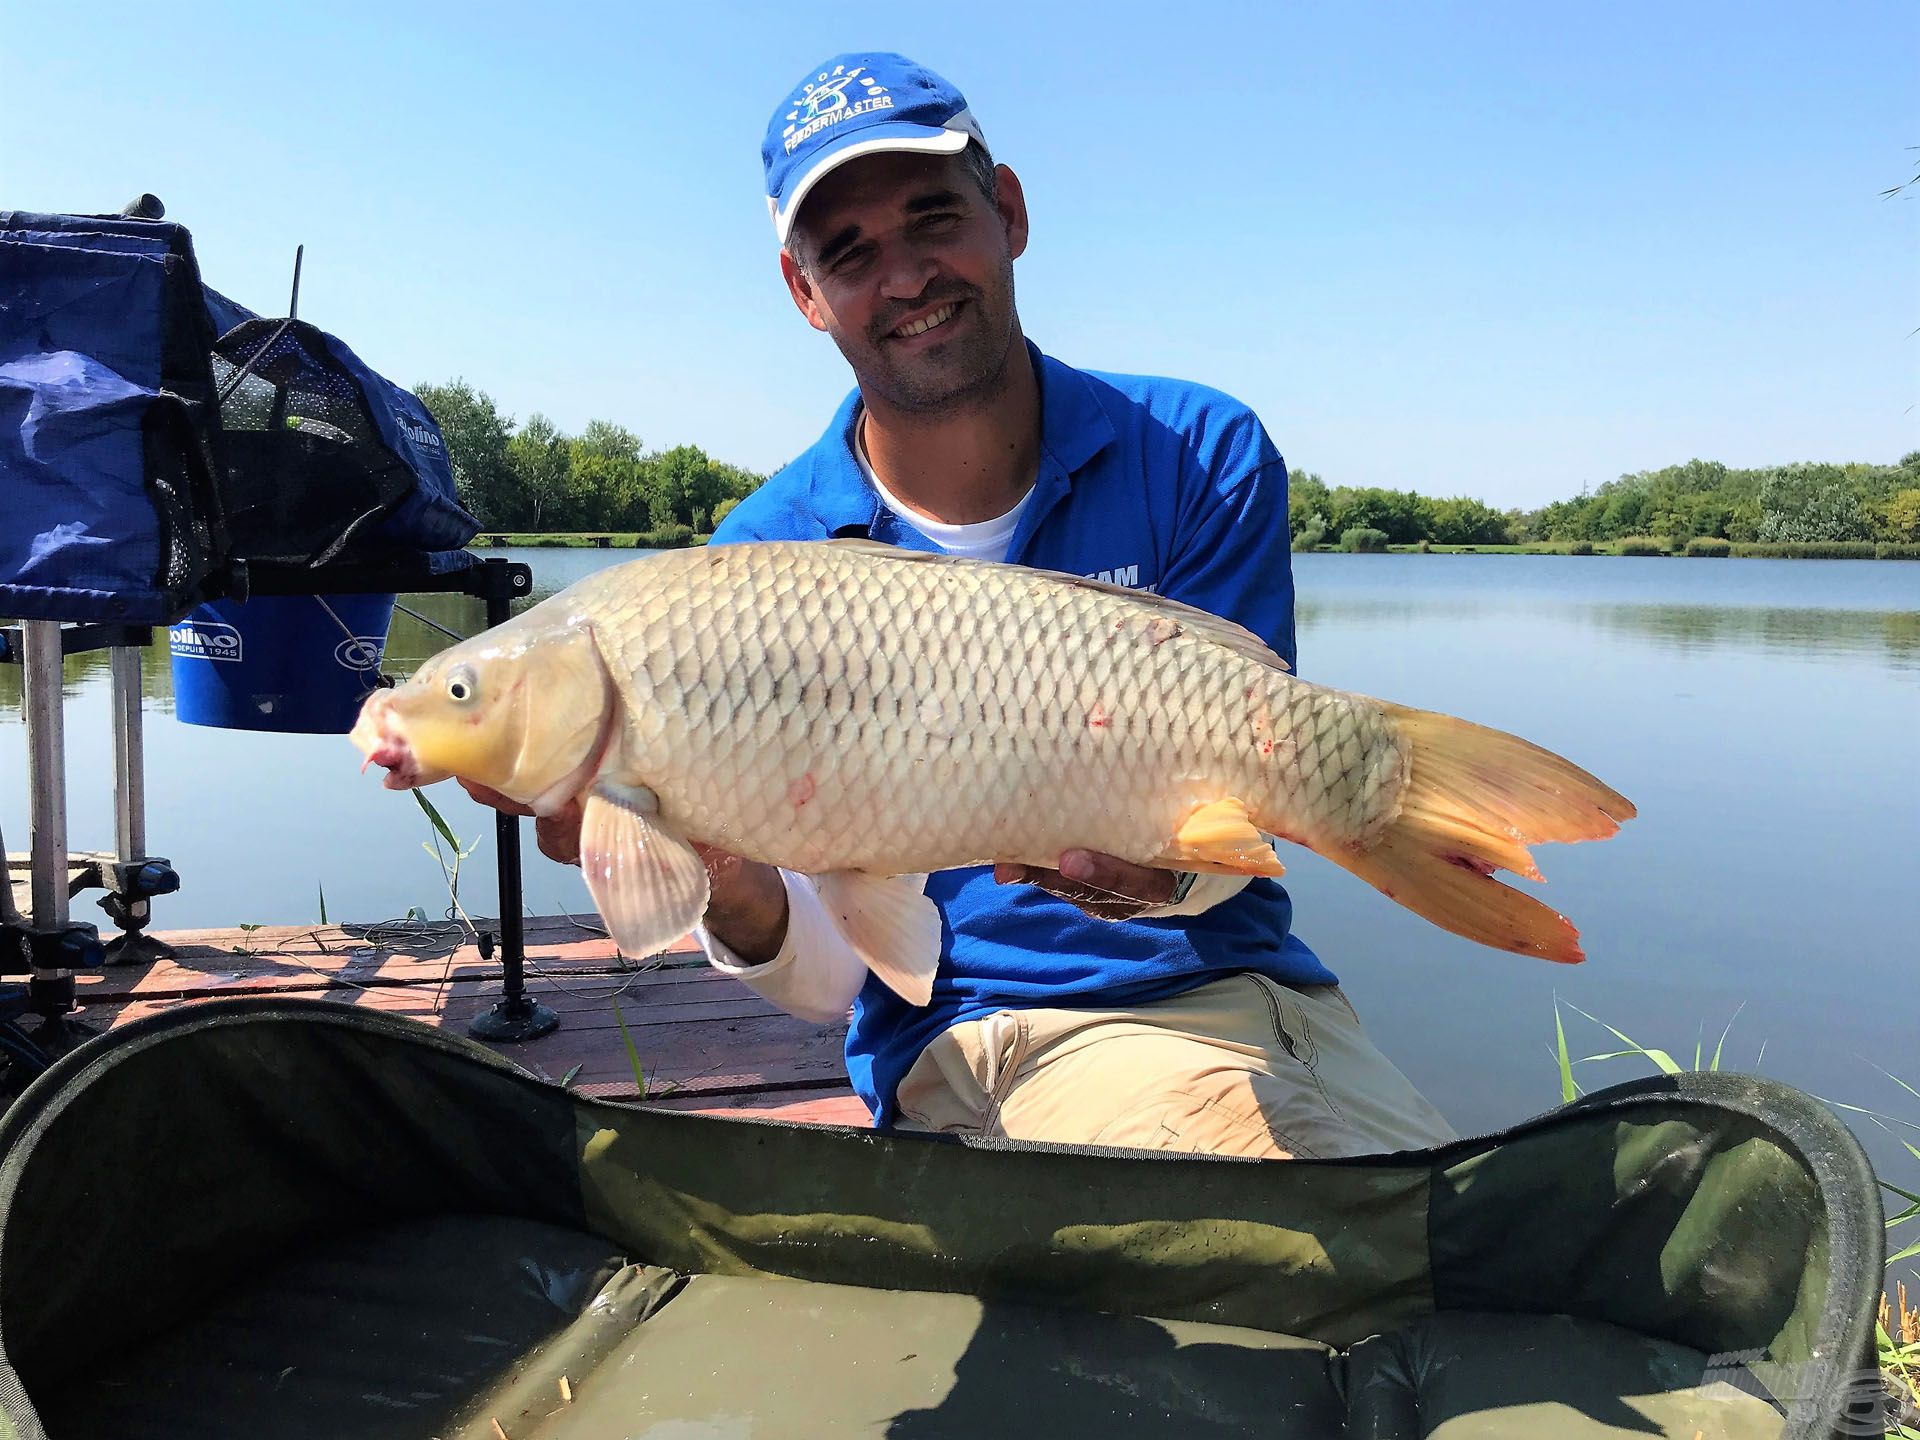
[415,380,766,538]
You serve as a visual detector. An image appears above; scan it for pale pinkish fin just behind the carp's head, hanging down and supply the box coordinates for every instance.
[580,781,707,960]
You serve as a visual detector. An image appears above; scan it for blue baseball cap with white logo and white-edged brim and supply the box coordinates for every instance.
[760,54,987,244]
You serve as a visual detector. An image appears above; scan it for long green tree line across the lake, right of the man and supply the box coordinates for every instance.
[1288,449,1920,549]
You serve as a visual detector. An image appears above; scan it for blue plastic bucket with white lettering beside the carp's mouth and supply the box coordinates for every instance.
[167,595,396,735]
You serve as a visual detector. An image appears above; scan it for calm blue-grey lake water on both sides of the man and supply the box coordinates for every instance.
[0,549,1920,1188]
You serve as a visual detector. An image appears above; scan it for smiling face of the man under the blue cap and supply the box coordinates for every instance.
[780,154,1027,413]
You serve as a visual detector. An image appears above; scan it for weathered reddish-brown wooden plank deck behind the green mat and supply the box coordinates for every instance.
[58,916,870,1125]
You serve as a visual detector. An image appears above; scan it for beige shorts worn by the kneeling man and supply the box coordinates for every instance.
[897,973,1457,1160]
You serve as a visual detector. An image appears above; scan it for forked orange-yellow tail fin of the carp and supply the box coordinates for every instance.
[1327,705,1636,964]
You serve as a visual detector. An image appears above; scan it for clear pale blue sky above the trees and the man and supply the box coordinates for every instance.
[0,0,1920,505]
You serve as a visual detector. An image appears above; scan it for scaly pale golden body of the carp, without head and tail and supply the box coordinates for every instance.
[572,543,1405,874]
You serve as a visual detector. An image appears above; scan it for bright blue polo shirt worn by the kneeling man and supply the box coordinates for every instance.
[712,342,1334,1123]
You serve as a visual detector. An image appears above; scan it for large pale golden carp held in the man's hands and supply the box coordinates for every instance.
[353,541,1634,1004]
